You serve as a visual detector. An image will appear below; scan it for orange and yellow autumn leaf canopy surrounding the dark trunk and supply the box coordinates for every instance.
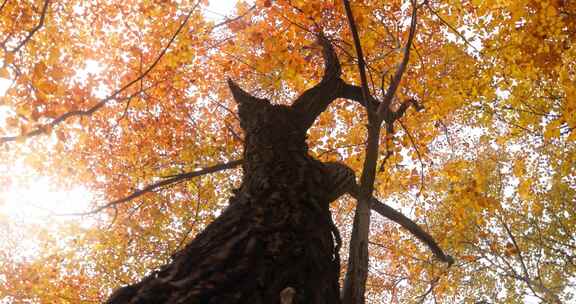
[0,0,576,303]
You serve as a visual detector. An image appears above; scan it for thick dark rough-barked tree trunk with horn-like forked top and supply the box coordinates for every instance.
[107,35,452,304]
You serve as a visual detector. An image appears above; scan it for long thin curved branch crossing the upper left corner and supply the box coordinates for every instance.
[0,0,200,143]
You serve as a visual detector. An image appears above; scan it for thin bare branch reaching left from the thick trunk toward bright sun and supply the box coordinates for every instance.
[58,160,243,216]
